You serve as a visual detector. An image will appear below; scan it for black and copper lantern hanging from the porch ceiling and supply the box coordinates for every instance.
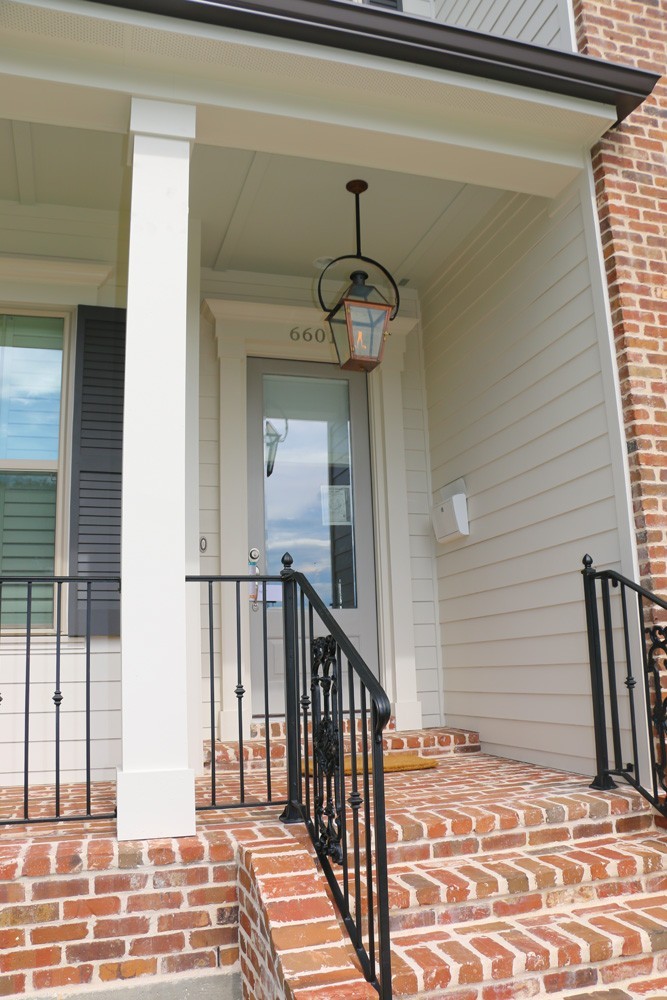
[317,180,400,372]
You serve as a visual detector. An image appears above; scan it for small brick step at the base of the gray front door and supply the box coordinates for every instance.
[204,724,480,769]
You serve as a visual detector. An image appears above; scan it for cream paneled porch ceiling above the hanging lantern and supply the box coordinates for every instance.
[0,120,502,288]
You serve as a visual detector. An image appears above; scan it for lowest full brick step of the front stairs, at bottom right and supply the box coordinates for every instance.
[392,893,667,1000]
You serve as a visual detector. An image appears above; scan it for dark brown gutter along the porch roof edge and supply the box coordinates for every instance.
[86,0,660,121]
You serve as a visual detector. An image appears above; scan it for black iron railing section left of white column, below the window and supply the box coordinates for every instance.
[0,576,120,824]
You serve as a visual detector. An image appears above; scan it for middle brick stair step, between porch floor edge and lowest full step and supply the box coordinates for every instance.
[389,835,667,931]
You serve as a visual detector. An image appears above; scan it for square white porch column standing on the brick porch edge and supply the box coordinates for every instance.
[117,98,195,840]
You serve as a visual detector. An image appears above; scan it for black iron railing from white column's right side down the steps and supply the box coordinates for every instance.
[187,554,392,1000]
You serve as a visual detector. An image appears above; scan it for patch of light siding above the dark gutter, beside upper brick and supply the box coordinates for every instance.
[435,0,570,49]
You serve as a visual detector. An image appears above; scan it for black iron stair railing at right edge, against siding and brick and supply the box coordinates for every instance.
[582,555,667,815]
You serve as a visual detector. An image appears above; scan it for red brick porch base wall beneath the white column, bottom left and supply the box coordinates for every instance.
[0,831,238,997]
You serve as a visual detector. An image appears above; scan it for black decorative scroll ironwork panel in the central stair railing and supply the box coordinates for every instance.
[310,635,343,864]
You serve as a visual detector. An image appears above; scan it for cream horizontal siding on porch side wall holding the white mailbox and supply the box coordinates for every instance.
[422,195,621,773]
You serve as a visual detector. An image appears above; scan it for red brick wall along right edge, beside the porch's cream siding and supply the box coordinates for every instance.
[573,0,667,593]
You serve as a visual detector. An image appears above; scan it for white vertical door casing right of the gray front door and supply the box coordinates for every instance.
[368,335,422,730]
